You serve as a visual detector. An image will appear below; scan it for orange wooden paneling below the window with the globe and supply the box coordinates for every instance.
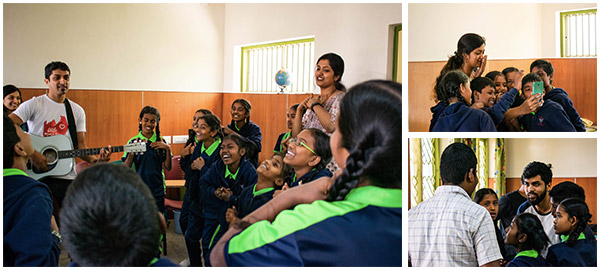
[222,93,308,162]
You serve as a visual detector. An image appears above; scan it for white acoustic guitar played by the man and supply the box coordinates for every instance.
[26,134,146,180]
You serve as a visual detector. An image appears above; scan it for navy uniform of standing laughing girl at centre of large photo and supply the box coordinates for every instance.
[199,158,258,265]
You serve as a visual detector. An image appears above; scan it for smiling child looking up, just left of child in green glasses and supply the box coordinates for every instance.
[225,152,292,227]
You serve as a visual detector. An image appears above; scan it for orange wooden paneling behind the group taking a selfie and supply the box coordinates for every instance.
[408,58,597,132]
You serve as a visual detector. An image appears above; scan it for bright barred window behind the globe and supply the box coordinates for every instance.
[241,37,315,93]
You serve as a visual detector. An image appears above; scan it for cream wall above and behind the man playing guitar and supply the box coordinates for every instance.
[3,4,225,92]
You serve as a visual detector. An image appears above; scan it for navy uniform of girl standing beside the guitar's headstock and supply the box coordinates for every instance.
[121,131,167,213]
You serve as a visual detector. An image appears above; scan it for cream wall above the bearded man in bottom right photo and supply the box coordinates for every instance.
[505,139,597,177]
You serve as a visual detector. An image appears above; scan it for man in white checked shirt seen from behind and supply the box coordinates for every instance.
[407,143,502,267]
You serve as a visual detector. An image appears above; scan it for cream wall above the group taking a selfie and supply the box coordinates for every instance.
[406,3,596,61]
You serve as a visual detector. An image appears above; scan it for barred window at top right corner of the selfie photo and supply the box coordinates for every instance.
[560,9,598,57]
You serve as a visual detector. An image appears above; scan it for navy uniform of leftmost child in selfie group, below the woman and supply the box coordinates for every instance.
[433,102,496,132]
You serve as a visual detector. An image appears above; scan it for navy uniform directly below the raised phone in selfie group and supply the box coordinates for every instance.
[519,100,576,132]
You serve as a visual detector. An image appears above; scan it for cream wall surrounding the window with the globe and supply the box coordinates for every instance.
[223,4,402,92]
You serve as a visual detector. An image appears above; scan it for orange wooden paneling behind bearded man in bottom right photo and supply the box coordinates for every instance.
[506,177,598,224]
